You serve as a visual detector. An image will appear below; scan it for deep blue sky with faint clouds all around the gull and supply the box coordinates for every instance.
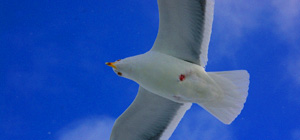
[0,0,300,140]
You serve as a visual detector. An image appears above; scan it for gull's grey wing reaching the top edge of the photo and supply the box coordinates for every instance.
[152,0,214,67]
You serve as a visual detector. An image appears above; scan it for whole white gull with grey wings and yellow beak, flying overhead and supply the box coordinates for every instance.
[105,0,250,140]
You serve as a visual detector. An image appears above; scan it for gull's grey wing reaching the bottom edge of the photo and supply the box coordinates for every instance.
[110,87,192,140]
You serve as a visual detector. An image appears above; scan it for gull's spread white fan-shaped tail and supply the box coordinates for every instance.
[199,70,249,124]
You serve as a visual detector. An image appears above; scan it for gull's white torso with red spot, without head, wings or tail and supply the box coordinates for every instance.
[120,51,223,103]
